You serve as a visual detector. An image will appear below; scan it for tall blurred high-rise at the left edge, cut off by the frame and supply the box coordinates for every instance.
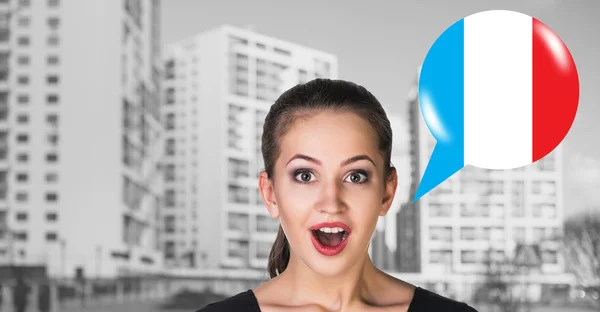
[0,0,162,276]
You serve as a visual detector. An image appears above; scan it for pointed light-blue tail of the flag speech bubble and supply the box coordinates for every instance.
[412,144,464,203]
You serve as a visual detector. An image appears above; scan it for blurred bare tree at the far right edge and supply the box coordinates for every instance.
[563,210,600,309]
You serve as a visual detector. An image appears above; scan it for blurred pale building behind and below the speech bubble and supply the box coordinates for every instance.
[397,67,570,296]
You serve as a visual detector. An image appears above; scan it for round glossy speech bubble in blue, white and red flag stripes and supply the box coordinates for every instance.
[413,10,579,202]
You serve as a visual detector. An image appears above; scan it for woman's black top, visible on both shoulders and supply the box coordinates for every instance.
[196,287,477,312]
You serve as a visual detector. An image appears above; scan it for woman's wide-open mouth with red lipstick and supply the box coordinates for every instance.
[310,222,351,256]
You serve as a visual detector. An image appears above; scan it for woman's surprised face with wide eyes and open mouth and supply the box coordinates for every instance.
[261,112,396,276]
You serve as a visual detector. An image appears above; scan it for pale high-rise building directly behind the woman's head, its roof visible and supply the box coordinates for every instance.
[162,25,338,269]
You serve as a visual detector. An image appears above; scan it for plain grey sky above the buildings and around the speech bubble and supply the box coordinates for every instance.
[162,0,600,215]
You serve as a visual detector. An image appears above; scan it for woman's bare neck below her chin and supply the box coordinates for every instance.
[281,253,377,311]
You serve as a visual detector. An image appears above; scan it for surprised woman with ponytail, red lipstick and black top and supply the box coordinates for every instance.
[198,79,475,312]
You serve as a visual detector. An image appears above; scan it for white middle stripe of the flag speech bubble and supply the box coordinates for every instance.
[464,11,533,169]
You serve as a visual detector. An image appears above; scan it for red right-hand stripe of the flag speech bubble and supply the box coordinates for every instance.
[532,18,579,162]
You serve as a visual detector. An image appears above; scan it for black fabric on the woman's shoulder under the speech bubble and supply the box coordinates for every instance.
[408,287,477,312]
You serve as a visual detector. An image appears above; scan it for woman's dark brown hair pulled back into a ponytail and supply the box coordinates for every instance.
[262,78,393,278]
